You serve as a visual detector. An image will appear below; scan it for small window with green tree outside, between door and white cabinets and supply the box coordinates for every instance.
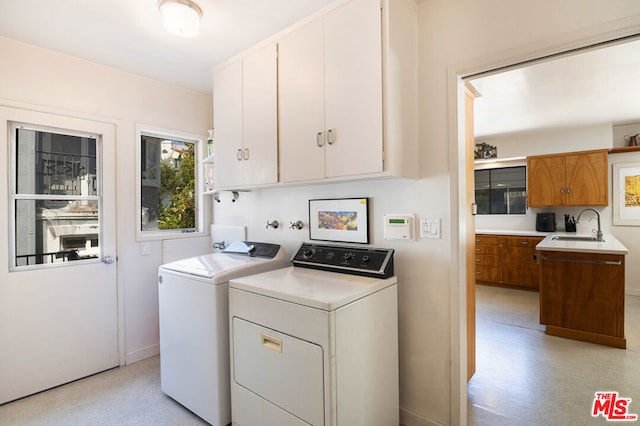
[138,131,201,238]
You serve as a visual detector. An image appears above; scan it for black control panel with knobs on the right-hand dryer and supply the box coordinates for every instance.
[291,243,394,278]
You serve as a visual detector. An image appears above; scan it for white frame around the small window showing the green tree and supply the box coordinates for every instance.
[135,124,207,241]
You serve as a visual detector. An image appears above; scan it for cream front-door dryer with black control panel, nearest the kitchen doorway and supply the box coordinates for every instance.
[229,243,399,426]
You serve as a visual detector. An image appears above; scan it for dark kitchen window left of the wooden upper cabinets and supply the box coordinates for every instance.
[475,166,527,214]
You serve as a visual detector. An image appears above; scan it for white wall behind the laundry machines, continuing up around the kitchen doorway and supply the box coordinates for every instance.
[214,0,640,425]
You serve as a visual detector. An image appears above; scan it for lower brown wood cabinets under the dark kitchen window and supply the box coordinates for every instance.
[476,234,542,289]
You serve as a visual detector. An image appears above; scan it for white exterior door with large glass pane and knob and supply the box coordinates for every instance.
[0,107,119,403]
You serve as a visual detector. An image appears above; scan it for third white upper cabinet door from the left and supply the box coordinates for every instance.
[278,19,325,182]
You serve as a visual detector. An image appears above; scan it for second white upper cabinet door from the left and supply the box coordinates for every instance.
[242,43,278,185]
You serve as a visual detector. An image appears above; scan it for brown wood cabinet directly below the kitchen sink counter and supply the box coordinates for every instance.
[539,251,626,348]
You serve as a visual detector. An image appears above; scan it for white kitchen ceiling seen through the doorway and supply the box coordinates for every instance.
[470,40,640,138]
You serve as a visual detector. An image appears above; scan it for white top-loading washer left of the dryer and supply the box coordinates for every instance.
[158,241,291,426]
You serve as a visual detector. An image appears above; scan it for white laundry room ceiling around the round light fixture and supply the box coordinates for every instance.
[0,0,335,93]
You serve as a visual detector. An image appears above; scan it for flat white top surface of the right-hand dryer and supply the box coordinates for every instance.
[229,267,397,311]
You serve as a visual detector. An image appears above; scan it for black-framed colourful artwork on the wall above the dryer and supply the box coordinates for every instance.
[309,198,369,244]
